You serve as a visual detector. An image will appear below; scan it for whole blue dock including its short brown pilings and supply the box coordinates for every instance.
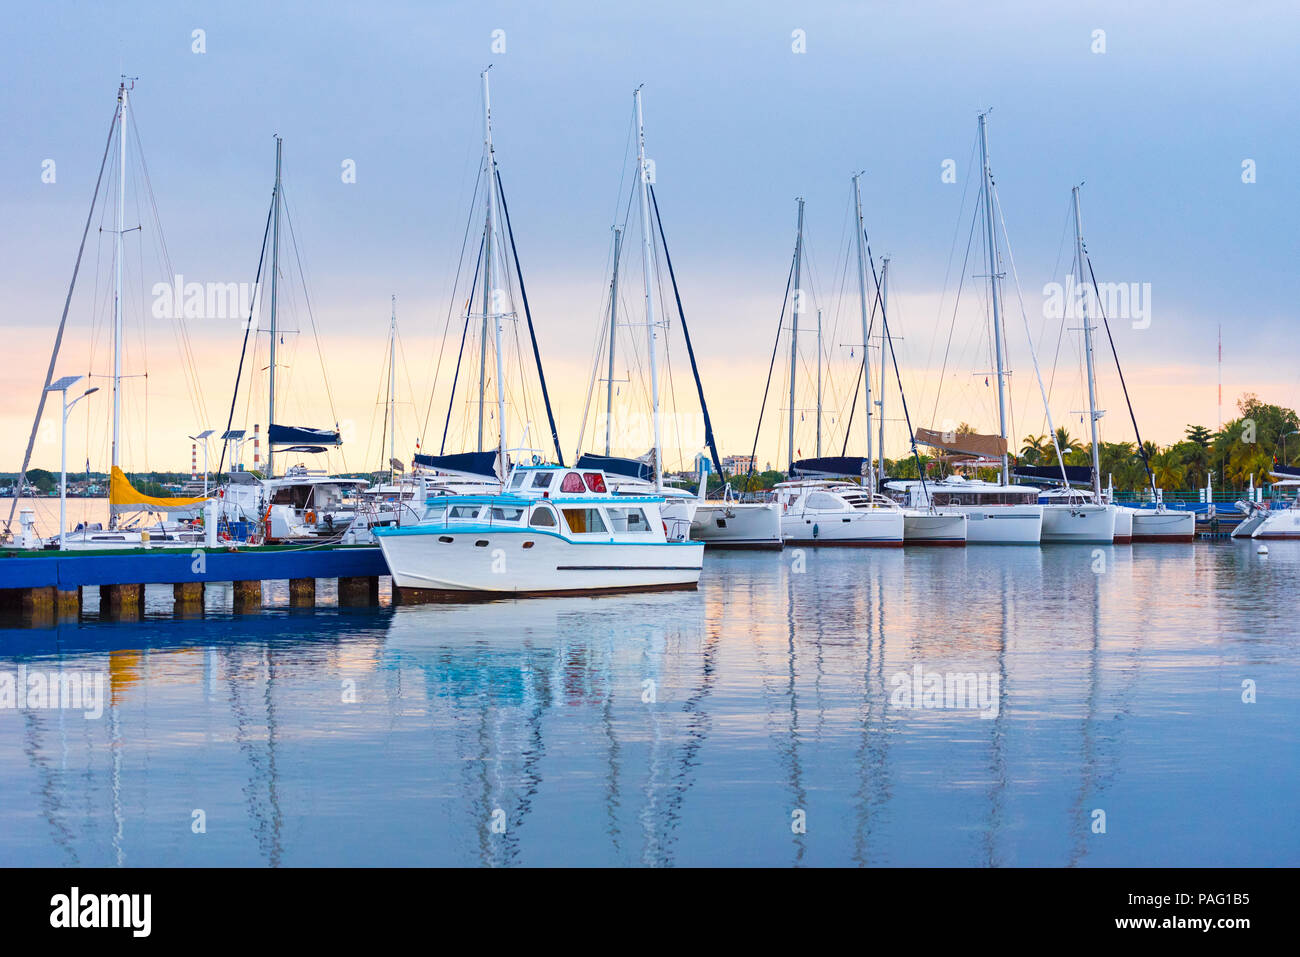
[0,545,389,619]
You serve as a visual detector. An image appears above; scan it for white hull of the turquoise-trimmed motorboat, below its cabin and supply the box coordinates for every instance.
[374,525,705,596]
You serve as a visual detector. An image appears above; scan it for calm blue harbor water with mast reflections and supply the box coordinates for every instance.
[0,544,1300,866]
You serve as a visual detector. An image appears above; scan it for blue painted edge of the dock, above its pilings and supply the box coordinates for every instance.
[0,545,389,592]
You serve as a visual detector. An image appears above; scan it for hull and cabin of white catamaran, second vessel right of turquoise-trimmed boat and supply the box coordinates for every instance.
[772,480,904,547]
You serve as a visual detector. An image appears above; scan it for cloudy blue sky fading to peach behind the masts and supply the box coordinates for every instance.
[0,1,1300,471]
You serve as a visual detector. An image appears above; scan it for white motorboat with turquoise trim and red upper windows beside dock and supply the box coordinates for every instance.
[373,465,705,598]
